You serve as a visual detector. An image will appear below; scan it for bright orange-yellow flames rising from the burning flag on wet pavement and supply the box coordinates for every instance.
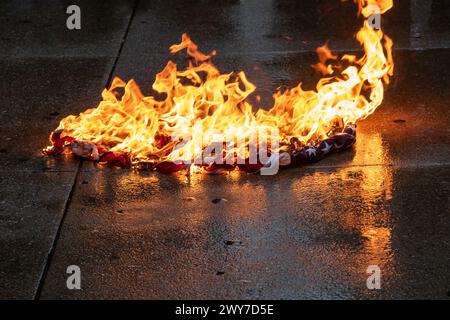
[46,0,394,171]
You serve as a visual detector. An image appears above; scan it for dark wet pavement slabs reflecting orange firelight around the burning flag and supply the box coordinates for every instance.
[0,0,450,299]
